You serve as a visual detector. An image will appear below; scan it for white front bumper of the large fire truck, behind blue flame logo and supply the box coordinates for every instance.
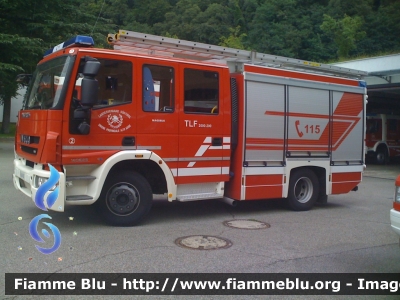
[13,156,65,212]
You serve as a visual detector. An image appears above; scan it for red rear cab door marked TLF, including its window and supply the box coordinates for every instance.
[177,66,230,184]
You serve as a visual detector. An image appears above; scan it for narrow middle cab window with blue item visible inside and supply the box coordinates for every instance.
[142,65,174,112]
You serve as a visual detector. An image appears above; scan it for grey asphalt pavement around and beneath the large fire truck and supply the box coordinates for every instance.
[0,140,400,299]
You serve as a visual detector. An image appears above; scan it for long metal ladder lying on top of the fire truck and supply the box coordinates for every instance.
[107,30,368,78]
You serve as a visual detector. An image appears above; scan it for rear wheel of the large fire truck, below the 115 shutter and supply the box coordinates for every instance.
[287,169,319,211]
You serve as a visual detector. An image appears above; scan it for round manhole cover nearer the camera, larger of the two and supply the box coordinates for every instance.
[175,235,232,250]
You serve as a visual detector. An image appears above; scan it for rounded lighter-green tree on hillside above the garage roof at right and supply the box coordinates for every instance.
[321,15,365,58]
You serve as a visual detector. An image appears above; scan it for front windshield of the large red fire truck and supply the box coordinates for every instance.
[24,56,75,109]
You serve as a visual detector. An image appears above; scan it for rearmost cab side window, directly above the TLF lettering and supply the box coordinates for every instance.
[184,69,219,114]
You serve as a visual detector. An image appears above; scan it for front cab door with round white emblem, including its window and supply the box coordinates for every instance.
[63,57,136,165]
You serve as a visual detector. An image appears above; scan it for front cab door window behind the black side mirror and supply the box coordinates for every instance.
[74,58,133,108]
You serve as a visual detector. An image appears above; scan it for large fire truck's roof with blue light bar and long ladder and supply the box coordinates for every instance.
[42,30,368,82]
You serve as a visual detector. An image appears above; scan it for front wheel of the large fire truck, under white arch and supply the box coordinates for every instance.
[98,171,153,226]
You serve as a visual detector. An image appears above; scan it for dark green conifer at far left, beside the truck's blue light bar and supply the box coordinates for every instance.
[0,0,109,133]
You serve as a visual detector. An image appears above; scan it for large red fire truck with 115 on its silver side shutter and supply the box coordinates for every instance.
[13,30,366,225]
